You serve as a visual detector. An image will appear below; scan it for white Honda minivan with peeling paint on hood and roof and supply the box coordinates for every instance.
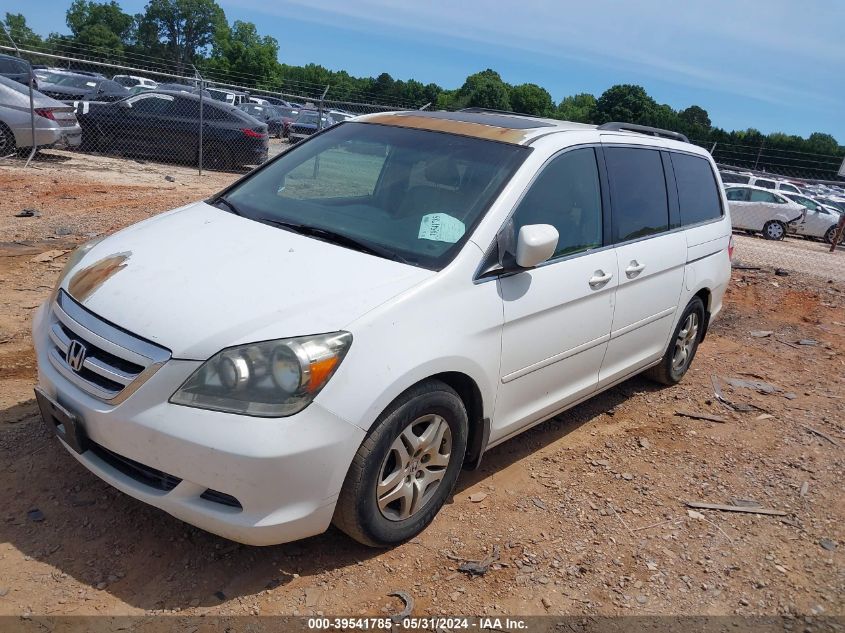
[33,110,733,546]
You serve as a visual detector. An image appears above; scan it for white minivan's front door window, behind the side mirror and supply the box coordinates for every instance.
[513,148,600,257]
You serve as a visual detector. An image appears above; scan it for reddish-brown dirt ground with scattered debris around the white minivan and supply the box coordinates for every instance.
[0,158,845,616]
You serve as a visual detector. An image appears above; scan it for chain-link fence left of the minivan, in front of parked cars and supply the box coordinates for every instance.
[0,45,418,174]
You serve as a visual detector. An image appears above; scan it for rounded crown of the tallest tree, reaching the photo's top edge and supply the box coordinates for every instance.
[138,0,226,66]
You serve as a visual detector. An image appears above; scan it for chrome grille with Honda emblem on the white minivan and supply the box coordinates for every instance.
[48,291,170,404]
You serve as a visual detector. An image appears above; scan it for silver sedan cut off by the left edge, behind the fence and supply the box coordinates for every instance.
[0,76,82,157]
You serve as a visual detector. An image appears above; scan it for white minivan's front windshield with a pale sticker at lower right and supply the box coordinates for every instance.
[224,123,530,270]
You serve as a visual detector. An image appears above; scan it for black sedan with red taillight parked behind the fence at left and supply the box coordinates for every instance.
[79,91,268,170]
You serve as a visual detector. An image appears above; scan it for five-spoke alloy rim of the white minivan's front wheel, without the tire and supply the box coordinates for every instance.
[376,414,452,521]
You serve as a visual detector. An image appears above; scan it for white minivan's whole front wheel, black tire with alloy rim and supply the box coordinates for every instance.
[332,380,469,547]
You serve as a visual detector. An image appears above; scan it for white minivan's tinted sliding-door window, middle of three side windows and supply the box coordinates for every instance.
[604,147,669,242]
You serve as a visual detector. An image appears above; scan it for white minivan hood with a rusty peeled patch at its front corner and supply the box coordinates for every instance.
[61,202,434,360]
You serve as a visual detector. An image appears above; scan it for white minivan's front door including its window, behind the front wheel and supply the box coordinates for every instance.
[490,147,618,441]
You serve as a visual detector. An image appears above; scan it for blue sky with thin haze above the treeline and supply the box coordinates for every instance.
[6,0,845,144]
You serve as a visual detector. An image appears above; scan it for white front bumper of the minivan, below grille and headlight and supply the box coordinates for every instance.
[33,307,364,545]
